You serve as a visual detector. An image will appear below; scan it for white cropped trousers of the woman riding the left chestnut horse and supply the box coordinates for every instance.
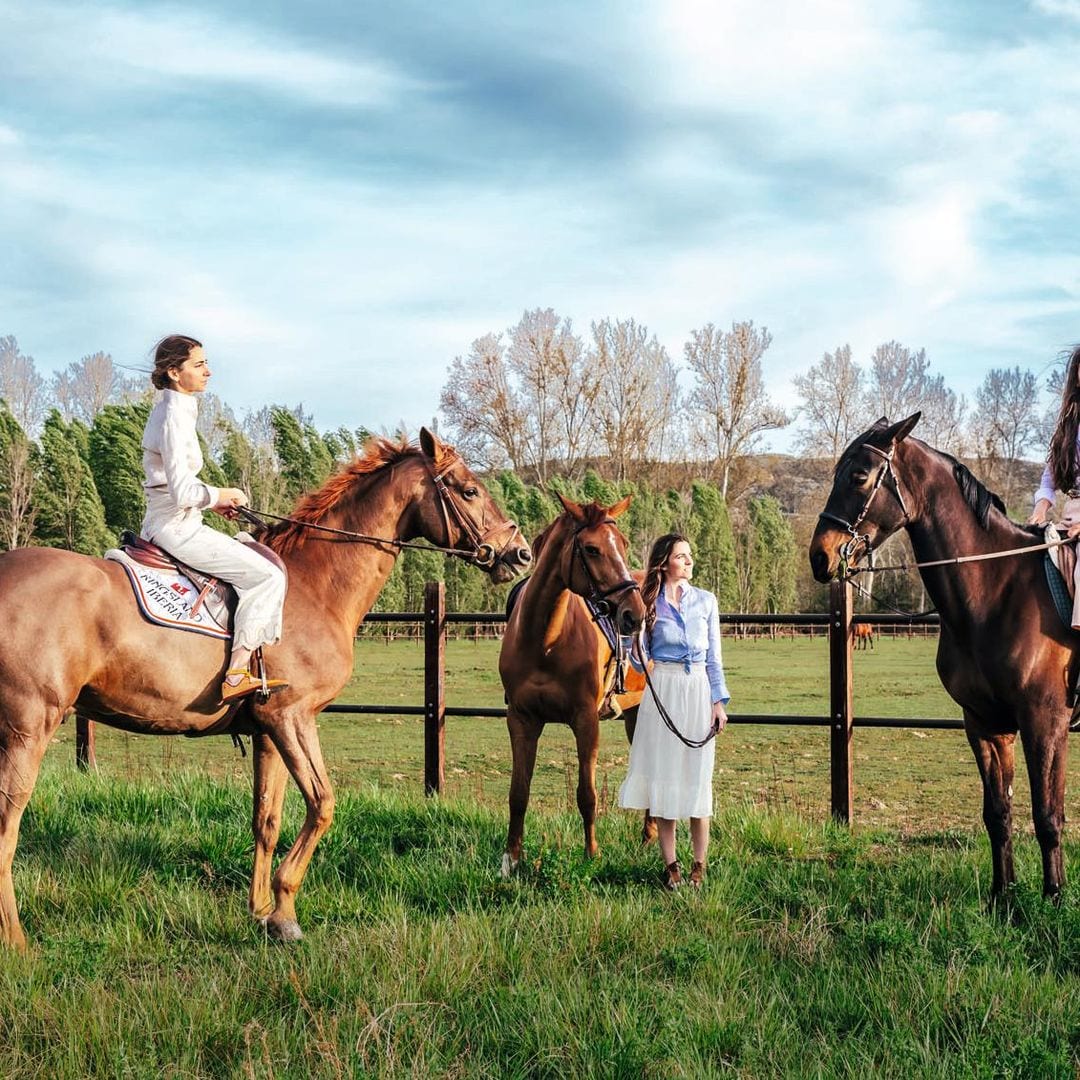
[143,499,285,649]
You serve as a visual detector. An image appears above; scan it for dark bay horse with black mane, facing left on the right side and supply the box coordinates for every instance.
[810,413,1080,899]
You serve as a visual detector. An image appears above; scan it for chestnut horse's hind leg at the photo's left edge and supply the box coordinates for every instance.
[0,701,64,950]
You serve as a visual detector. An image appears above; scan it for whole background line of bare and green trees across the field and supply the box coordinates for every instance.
[0,319,1061,611]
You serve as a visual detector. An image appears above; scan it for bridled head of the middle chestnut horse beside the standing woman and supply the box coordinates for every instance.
[556,492,645,634]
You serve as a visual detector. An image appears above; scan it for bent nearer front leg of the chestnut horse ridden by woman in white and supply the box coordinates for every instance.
[260,713,334,942]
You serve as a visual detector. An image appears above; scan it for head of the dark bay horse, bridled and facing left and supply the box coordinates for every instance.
[810,413,922,581]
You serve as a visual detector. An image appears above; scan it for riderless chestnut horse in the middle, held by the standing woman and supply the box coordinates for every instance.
[499,496,645,877]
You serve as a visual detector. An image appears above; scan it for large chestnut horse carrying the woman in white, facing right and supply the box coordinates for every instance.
[0,431,530,947]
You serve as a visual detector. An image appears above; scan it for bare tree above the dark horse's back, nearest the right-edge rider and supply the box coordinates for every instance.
[971,366,1040,503]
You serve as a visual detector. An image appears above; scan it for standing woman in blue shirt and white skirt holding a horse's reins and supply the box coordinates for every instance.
[619,532,729,890]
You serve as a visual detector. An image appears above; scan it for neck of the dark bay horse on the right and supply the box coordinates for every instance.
[901,441,1039,629]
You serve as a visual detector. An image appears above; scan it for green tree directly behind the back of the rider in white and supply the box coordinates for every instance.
[90,402,150,532]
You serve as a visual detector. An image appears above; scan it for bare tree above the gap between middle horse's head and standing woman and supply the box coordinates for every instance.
[592,319,678,480]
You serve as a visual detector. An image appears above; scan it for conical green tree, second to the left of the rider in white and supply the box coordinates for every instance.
[35,408,116,555]
